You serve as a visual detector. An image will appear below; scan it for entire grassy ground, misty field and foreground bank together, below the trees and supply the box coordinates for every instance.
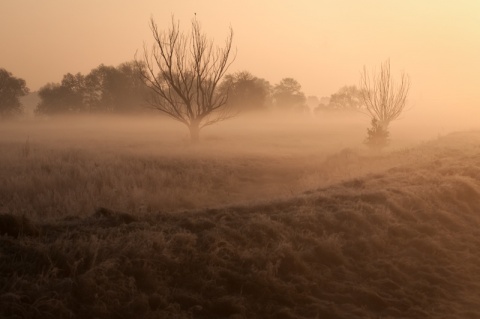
[0,118,480,318]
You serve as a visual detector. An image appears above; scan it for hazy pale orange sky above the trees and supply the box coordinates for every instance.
[0,0,480,120]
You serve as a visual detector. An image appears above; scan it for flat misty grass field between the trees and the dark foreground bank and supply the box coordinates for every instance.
[0,114,420,219]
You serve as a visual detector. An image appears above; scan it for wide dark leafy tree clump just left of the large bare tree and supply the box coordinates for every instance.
[35,62,146,115]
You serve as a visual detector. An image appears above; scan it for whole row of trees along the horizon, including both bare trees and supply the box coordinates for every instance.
[0,17,410,149]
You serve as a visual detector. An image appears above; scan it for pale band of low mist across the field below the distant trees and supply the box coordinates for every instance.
[0,108,470,153]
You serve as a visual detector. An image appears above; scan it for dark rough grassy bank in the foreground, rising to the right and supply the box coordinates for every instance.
[0,132,480,318]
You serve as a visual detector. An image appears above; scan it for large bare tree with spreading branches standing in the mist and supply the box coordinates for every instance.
[137,17,236,143]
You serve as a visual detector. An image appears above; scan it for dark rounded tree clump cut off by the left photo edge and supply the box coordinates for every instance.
[0,68,29,117]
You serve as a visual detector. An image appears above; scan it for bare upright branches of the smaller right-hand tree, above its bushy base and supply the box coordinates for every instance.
[360,60,410,129]
